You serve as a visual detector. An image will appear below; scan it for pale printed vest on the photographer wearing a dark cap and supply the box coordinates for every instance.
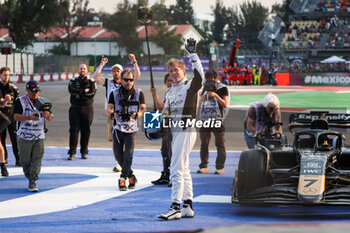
[14,95,45,141]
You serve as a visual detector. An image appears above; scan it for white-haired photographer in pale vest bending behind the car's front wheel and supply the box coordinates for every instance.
[244,93,284,149]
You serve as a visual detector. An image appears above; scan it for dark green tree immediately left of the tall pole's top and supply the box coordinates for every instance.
[102,0,147,54]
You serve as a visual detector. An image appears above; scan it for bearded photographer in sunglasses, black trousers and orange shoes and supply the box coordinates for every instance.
[106,69,146,191]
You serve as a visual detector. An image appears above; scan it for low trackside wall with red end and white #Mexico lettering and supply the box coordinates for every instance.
[275,72,350,86]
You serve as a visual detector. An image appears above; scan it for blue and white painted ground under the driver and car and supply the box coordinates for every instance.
[0,147,350,232]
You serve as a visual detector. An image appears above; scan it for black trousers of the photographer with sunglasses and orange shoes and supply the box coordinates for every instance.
[113,130,137,179]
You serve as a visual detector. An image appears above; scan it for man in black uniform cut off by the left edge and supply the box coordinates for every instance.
[0,67,21,166]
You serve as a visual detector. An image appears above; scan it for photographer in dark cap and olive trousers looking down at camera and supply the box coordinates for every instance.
[14,81,54,192]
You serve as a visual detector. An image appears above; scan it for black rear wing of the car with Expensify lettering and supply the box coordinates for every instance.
[288,111,350,134]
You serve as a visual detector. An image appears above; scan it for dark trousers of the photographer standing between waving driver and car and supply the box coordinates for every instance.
[199,124,226,170]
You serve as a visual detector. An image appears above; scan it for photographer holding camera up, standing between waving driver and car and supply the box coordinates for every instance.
[197,70,229,174]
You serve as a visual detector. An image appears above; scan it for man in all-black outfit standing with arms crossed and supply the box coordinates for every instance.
[68,64,97,160]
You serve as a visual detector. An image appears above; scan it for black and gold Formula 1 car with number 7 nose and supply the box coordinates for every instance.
[232,112,350,205]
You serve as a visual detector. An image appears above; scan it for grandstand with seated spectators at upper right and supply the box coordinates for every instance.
[259,0,350,64]
